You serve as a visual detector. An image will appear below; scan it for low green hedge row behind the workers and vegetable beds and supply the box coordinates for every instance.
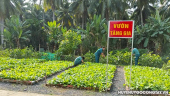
[0,48,165,68]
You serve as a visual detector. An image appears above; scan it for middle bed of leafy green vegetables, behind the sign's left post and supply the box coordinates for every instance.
[47,62,116,91]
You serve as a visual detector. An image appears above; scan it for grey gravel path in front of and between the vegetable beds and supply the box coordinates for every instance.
[0,67,125,96]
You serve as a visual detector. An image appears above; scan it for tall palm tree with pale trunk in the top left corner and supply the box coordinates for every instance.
[0,0,20,44]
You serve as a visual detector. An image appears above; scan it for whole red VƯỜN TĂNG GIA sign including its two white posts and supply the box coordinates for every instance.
[106,20,134,91]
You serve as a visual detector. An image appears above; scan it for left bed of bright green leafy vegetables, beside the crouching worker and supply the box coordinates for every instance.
[0,61,73,81]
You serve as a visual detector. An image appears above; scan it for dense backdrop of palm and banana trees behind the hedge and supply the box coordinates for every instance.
[0,0,170,54]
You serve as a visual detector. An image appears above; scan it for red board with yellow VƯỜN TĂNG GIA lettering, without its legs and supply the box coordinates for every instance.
[108,21,133,38]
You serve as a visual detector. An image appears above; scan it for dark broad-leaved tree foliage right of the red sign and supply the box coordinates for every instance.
[135,17,170,53]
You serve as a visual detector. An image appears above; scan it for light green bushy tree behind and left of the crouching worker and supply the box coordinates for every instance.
[58,30,81,55]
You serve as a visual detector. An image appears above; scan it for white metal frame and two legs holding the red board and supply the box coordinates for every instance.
[106,20,134,92]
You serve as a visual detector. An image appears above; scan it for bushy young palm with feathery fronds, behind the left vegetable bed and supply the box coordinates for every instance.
[4,16,30,48]
